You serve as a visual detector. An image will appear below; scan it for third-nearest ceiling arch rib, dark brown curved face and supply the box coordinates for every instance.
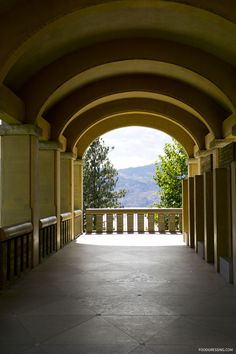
[44,75,229,139]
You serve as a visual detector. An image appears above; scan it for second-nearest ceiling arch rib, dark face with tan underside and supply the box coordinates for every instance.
[19,38,236,123]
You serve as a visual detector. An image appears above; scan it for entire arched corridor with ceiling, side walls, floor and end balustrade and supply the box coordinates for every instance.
[0,0,236,354]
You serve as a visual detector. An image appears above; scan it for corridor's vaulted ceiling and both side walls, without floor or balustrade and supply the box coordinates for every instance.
[0,0,236,314]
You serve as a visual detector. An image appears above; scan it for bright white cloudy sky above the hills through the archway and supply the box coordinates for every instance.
[102,127,171,169]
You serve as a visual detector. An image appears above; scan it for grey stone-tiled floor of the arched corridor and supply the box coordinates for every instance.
[0,235,236,354]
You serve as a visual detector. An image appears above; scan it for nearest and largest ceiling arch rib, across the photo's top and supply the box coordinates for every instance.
[0,0,236,84]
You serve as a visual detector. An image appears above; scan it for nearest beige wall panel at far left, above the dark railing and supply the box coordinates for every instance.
[0,135,31,226]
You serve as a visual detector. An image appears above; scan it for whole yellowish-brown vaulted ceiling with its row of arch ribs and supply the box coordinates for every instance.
[0,0,236,155]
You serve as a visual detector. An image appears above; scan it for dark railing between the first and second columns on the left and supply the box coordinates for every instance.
[39,216,57,263]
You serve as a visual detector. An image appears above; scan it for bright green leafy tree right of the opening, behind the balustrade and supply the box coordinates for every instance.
[154,139,188,208]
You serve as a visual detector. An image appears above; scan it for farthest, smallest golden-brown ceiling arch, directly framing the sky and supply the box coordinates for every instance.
[76,113,195,159]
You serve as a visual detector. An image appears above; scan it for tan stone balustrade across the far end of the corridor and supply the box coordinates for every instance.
[85,208,182,234]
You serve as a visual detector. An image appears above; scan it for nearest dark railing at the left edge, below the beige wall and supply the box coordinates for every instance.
[0,222,33,288]
